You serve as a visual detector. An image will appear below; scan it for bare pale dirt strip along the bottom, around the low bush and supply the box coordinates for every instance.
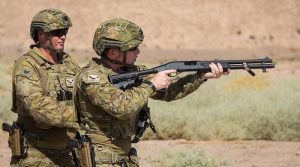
[0,132,300,167]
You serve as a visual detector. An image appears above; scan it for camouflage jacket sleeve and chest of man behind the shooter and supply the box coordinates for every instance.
[13,48,79,129]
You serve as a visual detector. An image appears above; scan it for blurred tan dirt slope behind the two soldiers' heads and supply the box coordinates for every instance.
[0,0,300,60]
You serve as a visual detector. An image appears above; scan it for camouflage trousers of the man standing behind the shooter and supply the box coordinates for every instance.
[10,146,75,167]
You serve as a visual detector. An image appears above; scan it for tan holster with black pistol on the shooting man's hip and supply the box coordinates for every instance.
[68,135,96,167]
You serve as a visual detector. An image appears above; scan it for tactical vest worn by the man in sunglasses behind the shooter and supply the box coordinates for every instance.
[12,50,79,149]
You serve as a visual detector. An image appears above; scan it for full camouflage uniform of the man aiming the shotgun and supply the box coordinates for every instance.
[73,19,209,167]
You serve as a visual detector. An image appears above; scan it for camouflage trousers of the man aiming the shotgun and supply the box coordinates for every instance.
[94,144,139,167]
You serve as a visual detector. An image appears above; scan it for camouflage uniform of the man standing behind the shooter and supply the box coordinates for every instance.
[12,47,79,166]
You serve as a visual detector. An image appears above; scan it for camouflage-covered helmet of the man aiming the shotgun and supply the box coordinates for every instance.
[93,18,144,56]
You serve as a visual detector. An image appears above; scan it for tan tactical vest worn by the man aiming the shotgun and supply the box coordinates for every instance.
[74,61,144,153]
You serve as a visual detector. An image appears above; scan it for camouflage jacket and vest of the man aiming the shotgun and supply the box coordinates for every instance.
[74,59,204,152]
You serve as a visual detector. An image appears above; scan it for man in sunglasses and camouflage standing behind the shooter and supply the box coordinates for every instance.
[11,9,80,167]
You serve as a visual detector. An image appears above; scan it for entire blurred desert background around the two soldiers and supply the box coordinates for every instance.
[0,0,300,166]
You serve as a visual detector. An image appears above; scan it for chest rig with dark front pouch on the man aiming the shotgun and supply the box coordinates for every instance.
[74,61,154,143]
